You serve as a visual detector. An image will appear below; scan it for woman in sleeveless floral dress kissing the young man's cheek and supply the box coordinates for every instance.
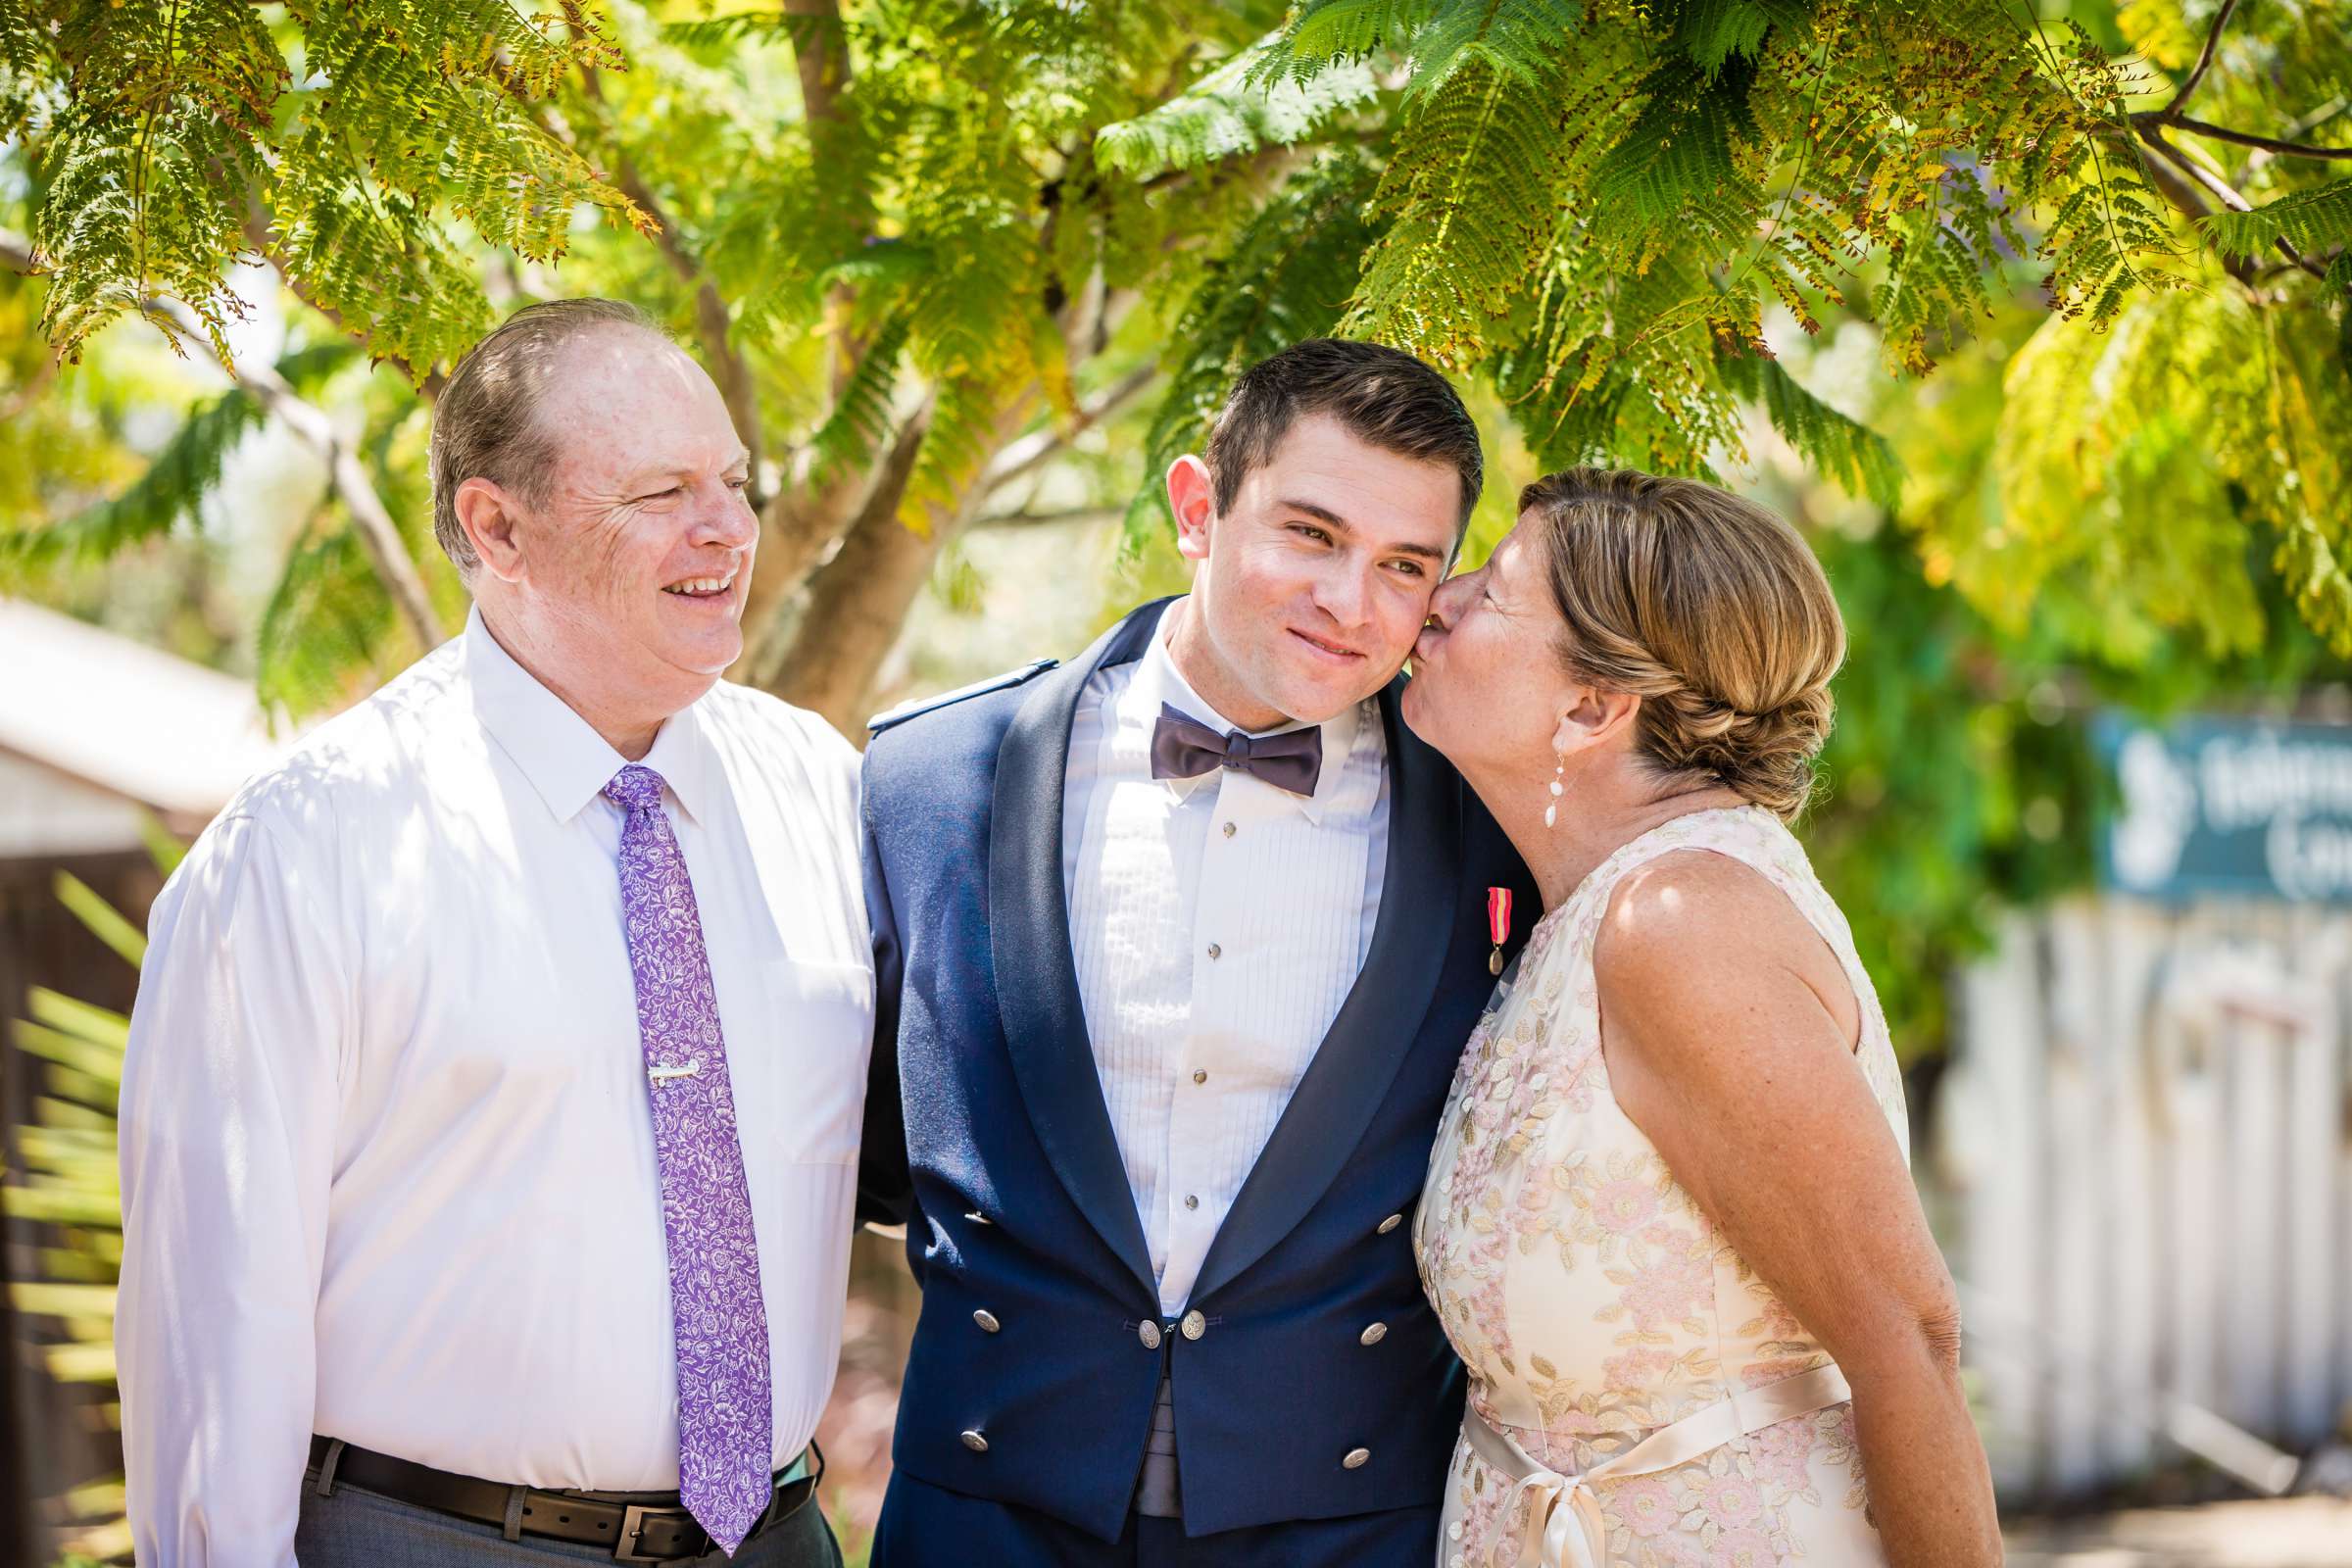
[1404,470,1999,1568]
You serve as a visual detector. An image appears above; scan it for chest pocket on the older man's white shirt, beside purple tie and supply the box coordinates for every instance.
[739,959,875,1166]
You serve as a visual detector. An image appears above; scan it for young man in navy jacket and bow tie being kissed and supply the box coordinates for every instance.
[860,341,1534,1568]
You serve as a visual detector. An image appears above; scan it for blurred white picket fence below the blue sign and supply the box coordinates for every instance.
[1931,898,2352,1497]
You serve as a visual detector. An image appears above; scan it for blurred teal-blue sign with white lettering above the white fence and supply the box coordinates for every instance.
[2093,714,2352,903]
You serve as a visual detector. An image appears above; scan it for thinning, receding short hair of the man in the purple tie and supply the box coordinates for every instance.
[425,299,670,573]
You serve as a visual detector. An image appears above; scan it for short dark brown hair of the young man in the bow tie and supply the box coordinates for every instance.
[1206,338,1487,538]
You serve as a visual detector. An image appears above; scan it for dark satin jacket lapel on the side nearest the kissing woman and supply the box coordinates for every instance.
[1193,679,1463,1300]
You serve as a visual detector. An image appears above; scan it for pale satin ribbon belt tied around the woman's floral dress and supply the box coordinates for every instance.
[1463,1361,1853,1568]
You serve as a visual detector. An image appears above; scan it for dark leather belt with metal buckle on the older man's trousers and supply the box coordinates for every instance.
[311,1437,825,1563]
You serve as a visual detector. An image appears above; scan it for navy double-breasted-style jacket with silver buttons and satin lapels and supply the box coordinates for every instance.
[860,602,1536,1543]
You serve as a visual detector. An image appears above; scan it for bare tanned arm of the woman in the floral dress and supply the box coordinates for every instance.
[1594,854,2001,1568]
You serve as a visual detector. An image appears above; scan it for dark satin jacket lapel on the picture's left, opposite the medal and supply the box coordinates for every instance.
[988,602,1164,1289]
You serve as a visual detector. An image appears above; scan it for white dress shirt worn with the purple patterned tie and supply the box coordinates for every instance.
[116,613,872,1568]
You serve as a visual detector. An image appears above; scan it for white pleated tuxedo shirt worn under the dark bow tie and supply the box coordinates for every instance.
[1060,607,1388,1316]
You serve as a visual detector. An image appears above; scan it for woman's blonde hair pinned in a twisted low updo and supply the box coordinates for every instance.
[1519,467,1846,820]
